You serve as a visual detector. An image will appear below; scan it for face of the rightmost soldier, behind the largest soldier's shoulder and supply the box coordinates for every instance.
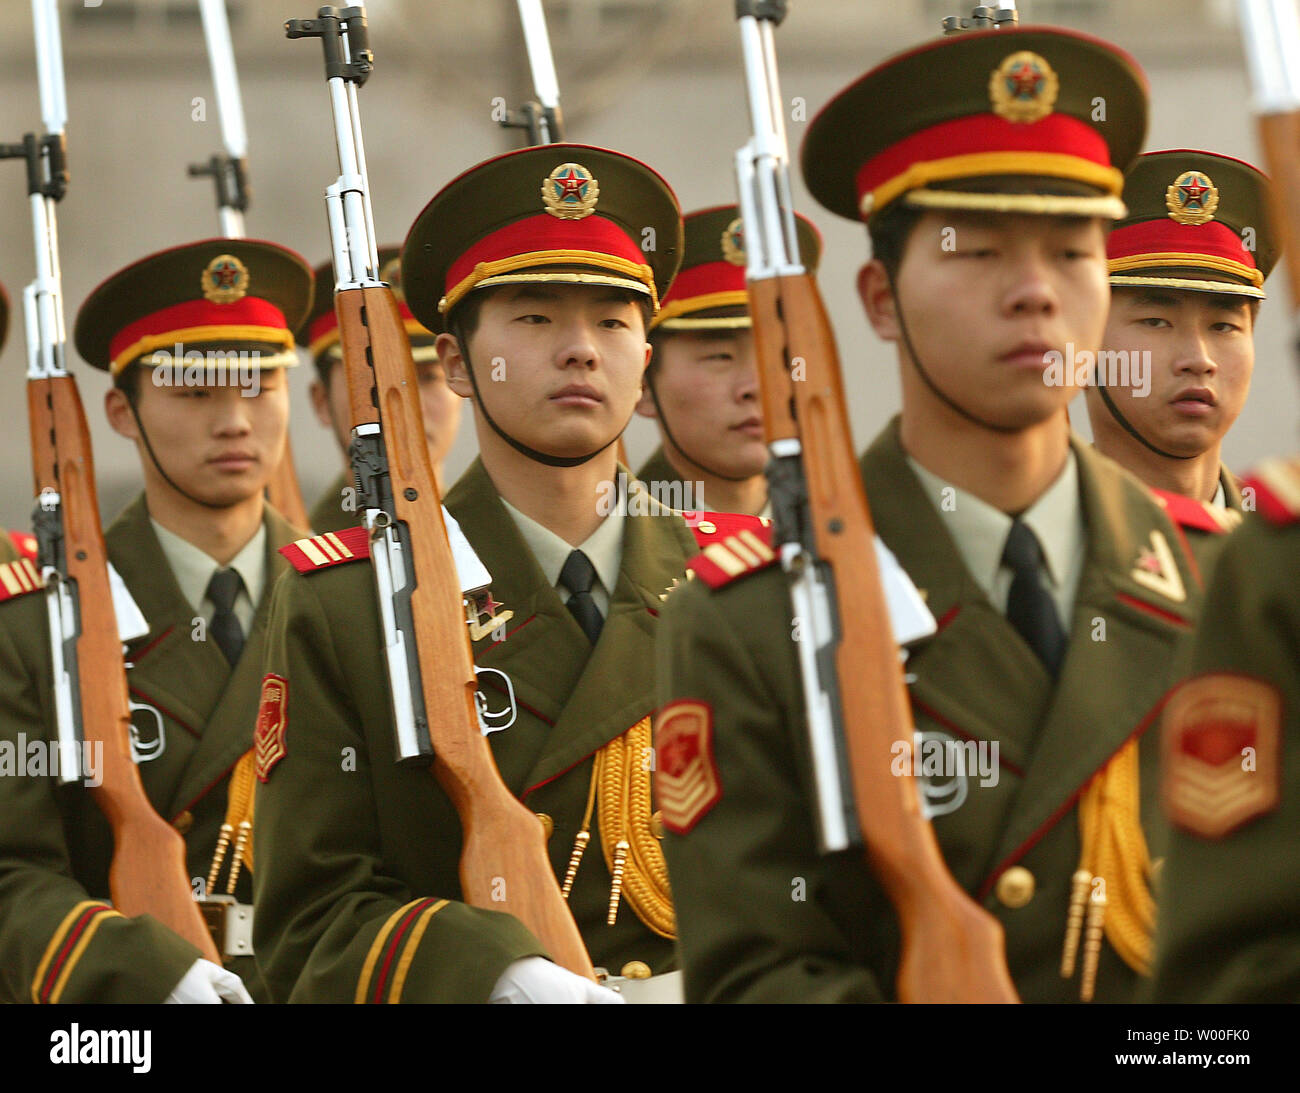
[1088,289,1255,456]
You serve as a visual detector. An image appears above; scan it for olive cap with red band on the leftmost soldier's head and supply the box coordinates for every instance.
[73,239,312,376]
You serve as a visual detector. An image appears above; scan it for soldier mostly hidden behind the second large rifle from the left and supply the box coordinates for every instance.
[298,247,460,533]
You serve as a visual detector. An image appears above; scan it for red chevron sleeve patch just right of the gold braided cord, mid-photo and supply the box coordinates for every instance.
[654,701,723,834]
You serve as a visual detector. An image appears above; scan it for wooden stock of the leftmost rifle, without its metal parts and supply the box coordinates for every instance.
[27,376,221,966]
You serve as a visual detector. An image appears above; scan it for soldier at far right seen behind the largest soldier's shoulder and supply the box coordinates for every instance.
[1087,149,1278,571]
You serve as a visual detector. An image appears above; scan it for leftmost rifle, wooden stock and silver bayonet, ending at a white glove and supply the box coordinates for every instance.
[0,0,221,964]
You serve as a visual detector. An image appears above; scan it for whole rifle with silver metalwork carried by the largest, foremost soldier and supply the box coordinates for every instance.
[736,0,1018,1002]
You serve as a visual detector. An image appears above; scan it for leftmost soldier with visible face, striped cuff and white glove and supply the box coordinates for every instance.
[0,239,312,1002]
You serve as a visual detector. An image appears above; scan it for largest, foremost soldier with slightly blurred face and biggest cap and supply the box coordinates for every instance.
[655,27,1199,1001]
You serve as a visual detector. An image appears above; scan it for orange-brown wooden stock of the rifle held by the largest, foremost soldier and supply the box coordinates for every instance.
[749,274,1019,1002]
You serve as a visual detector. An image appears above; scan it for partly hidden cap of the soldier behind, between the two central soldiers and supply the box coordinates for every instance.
[650,205,822,330]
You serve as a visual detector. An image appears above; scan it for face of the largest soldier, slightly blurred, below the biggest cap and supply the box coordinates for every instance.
[859,211,1110,429]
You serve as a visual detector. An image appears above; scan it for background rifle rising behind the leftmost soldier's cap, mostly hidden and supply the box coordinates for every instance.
[189,0,311,528]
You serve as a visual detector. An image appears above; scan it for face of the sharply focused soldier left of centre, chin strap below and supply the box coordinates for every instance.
[438,285,650,457]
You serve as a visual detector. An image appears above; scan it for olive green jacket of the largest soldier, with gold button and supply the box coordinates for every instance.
[658,418,1199,1002]
